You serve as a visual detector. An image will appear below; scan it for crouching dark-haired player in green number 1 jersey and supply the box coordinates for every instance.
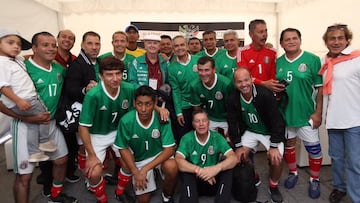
[114,86,178,203]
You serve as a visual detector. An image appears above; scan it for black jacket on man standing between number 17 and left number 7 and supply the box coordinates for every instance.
[64,50,96,103]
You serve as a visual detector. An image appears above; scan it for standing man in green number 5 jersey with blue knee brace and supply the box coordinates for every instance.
[276,28,323,199]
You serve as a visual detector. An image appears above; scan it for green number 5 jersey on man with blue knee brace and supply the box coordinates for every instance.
[276,51,322,127]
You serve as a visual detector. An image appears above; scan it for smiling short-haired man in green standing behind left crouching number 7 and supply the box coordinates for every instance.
[99,31,135,81]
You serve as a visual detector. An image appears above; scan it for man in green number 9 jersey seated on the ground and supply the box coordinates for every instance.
[175,109,238,203]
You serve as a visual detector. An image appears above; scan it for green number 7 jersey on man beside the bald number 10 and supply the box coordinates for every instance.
[190,74,233,122]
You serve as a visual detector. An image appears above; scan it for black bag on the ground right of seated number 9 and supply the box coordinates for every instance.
[231,161,257,202]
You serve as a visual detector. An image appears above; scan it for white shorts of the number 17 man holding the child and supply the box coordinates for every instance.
[10,119,68,174]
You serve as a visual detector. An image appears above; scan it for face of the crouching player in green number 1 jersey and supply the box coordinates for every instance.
[135,96,155,124]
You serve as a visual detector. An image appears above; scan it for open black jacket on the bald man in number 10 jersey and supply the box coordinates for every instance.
[227,85,285,148]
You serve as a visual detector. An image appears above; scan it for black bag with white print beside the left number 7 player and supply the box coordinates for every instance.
[55,95,82,134]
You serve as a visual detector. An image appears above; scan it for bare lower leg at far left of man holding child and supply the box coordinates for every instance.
[13,173,32,203]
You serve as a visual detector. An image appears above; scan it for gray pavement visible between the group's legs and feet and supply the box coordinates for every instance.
[0,145,351,203]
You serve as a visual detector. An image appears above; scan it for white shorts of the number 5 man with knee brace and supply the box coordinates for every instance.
[286,126,320,143]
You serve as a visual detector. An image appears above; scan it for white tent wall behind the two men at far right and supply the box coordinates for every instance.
[277,0,360,57]
